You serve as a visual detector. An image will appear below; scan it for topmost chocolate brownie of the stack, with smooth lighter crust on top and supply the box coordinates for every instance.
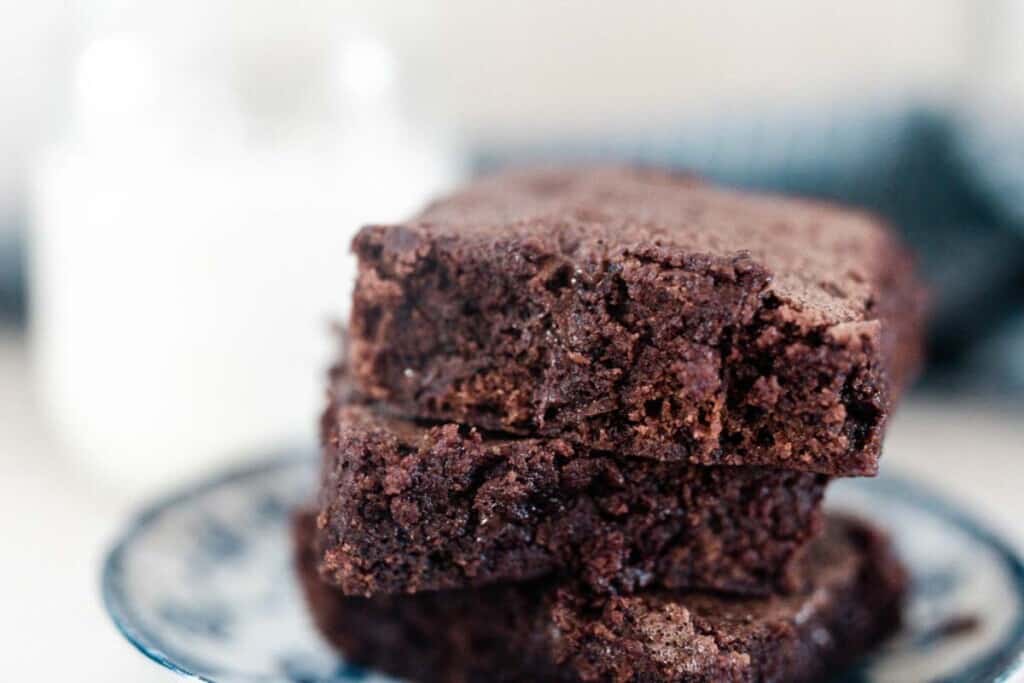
[348,167,923,475]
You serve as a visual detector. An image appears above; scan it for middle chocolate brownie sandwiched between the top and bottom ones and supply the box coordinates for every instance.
[317,403,827,596]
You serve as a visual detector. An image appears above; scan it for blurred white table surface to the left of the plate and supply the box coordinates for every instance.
[0,330,177,683]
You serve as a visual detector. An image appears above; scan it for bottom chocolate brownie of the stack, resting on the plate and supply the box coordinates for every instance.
[296,515,906,683]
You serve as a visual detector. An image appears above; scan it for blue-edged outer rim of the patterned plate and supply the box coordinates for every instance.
[100,454,1024,683]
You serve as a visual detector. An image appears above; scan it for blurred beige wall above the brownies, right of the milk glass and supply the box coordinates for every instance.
[417,0,985,137]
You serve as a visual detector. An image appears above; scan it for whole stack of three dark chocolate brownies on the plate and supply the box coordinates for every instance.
[295,168,922,683]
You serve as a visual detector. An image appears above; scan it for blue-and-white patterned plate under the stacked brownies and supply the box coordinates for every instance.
[102,451,1024,683]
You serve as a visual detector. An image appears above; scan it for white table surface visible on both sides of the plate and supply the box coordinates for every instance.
[0,329,1024,683]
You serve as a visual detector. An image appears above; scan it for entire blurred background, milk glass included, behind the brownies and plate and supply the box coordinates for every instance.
[0,0,1024,681]
